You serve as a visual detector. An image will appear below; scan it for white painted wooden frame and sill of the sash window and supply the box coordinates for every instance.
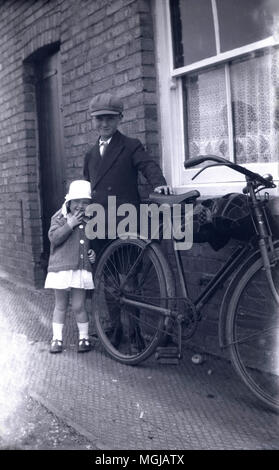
[154,0,279,195]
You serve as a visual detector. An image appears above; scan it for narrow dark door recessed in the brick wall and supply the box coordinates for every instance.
[36,51,66,262]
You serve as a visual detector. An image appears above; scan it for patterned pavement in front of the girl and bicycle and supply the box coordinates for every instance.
[0,279,279,450]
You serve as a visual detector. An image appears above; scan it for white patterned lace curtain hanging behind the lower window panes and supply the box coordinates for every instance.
[184,49,279,163]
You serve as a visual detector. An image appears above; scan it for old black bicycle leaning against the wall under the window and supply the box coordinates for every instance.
[93,155,279,411]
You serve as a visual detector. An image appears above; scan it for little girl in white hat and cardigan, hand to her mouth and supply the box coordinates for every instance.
[45,180,95,353]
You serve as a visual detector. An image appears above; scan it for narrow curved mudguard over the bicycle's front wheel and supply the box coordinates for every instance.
[218,240,279,348]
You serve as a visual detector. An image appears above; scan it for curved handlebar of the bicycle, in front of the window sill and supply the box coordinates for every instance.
[184,155,276,188]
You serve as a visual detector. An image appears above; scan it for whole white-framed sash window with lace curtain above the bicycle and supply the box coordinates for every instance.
[155,0,279,194]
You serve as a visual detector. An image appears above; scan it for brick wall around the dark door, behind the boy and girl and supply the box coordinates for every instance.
[0,0,159,286]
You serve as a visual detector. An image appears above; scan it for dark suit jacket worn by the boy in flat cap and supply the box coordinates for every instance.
[83,131,167,208]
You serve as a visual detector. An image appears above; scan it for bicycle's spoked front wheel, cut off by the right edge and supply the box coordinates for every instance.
[226,249,279,411]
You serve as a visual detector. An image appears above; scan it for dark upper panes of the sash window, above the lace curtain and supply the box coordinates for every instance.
[169,0,279,68]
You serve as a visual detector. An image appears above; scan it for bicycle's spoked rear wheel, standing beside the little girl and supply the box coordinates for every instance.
[93,239,174,365]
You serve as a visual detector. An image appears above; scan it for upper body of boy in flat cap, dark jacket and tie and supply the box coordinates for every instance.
[83,93,171,253]
